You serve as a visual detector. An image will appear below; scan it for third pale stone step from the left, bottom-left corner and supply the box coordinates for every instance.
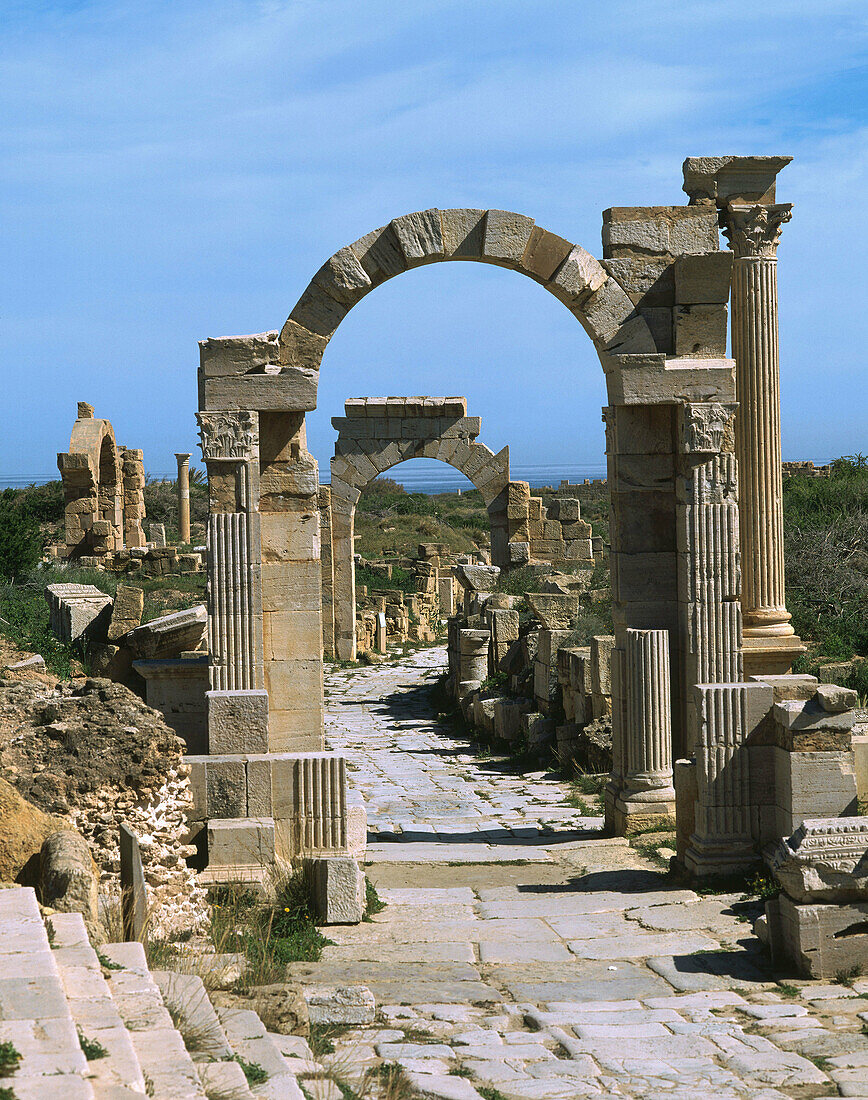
[102,943,206,1100]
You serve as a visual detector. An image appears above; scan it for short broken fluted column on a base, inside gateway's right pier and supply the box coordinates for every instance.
[616,629,675,834]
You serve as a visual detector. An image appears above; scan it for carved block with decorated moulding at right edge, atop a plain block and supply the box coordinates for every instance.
[769,817,868,902]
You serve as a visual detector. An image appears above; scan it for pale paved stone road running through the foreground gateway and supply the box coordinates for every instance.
[293,648,868,1100]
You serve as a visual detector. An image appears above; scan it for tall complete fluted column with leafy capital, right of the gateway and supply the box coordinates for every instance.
[722,202,801,674]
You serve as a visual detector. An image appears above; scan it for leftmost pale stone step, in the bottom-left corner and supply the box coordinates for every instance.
[0,887,95,1100]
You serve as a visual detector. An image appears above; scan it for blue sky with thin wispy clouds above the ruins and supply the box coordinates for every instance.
[0,0,868,476]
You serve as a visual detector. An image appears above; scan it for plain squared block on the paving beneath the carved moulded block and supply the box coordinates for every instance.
[766,894,868,978]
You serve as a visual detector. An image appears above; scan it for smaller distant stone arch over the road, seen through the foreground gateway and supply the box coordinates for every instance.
[330,397,510,660]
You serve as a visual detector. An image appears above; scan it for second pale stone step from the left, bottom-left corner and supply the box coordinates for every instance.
[47,913,145,1100]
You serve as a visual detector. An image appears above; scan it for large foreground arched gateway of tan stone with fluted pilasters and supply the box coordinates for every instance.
[191,158,800,884]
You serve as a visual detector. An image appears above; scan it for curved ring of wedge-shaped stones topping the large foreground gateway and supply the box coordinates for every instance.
[279,209,657,380]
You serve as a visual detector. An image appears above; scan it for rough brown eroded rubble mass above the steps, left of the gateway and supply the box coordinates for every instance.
[0,679,206,937]
